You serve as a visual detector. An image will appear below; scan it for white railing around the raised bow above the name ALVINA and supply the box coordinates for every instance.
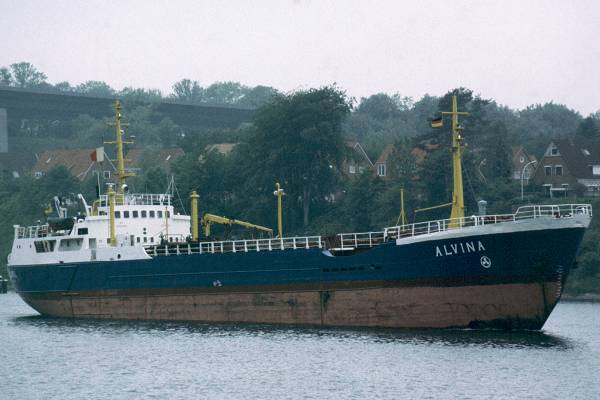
[383,204,592,240]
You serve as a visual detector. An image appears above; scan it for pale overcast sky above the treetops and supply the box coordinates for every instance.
[0,0,600,116]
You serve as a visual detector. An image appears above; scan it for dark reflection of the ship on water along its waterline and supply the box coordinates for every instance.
[12,315,575,350]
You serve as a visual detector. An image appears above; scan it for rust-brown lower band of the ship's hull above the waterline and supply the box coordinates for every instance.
[21,282,561,329]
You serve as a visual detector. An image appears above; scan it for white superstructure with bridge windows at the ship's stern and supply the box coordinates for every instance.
[9,194,190,265]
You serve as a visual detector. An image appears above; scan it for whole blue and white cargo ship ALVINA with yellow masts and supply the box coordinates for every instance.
[8,98,592,330]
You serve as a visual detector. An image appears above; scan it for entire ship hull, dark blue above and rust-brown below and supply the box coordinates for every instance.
[4,227,585,329]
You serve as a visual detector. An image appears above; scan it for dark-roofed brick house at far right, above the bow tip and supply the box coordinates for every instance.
[533,137,600,197]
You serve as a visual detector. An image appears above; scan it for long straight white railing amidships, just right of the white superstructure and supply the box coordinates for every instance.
[152,236,324,256]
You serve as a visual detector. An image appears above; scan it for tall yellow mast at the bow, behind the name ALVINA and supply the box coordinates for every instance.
[442,95,469,223]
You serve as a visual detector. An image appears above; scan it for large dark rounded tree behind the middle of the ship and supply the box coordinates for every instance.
[246,86,350,227]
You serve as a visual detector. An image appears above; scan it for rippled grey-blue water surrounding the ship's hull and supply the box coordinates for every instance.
[0,294,600,400]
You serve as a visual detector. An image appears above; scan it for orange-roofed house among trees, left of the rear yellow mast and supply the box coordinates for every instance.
[32,149,116,180]
